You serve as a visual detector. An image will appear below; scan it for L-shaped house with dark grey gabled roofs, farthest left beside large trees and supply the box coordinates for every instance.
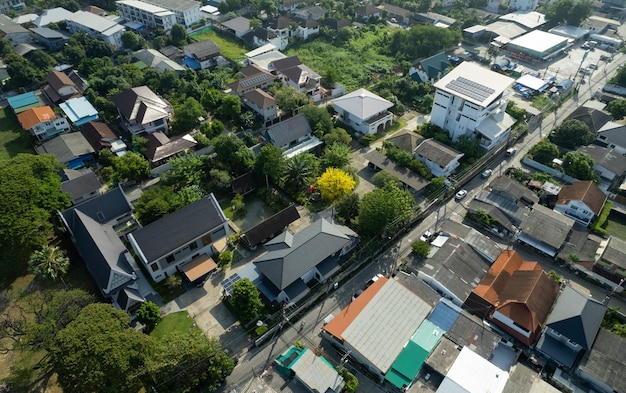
[61,188,147,312]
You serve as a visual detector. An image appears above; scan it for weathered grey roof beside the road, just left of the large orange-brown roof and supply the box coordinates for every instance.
[420,237,489,301]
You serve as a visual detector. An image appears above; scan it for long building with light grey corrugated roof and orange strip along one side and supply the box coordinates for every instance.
[322,277,433,382]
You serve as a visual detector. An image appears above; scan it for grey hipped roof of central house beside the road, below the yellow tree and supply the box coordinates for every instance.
[254,218,355,290]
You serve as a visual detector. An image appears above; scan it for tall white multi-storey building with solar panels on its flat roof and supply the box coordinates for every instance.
[430,62,515,150]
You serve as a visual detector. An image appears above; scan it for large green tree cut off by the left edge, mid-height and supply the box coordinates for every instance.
[0,154,70,270]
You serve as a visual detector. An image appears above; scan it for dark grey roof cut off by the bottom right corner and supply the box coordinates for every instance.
[579,329,626,392]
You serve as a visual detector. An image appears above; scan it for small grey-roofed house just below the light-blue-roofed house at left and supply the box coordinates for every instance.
[35,132,94,169]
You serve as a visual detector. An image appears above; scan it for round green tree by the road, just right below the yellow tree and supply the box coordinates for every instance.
[358,184,415,236]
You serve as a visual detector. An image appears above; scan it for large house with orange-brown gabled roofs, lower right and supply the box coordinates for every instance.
[463,250,559,346]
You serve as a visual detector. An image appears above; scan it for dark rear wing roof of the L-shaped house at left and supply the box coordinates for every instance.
[61,187,133,226]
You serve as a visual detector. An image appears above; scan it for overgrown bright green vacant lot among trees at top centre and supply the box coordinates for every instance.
[286,26,395,91]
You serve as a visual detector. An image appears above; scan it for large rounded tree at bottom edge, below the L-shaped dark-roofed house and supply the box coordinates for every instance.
[50,303,152,393]
